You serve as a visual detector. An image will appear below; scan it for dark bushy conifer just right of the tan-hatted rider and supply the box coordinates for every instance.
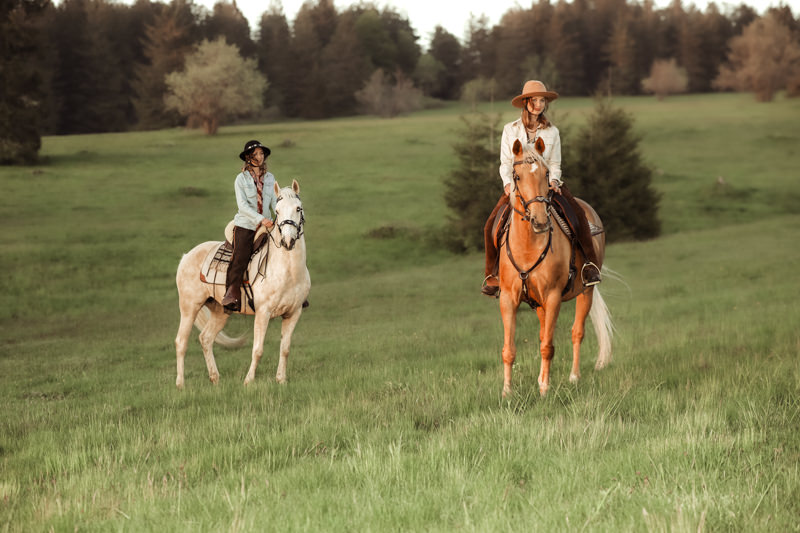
[562,98,661,241]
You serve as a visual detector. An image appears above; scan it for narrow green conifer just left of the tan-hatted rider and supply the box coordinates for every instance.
[444,113,503,251]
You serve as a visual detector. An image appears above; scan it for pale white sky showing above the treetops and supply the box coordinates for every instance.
[216,0,800,47]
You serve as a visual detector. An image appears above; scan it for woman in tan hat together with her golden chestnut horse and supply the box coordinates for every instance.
[483,82,613,396]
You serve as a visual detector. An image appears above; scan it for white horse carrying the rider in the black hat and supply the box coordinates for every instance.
[175,181,311,388]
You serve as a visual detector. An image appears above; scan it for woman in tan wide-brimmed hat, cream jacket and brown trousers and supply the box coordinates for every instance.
[481,80,600,296]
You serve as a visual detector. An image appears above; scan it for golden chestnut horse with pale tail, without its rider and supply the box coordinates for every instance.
[499,139,613,396]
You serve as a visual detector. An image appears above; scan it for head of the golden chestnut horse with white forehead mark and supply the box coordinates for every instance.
[512,139,551,233]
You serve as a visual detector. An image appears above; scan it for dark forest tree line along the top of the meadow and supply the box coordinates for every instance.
[0,0,800,160]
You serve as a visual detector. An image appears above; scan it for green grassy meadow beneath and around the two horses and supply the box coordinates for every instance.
[0,95,800,532]
